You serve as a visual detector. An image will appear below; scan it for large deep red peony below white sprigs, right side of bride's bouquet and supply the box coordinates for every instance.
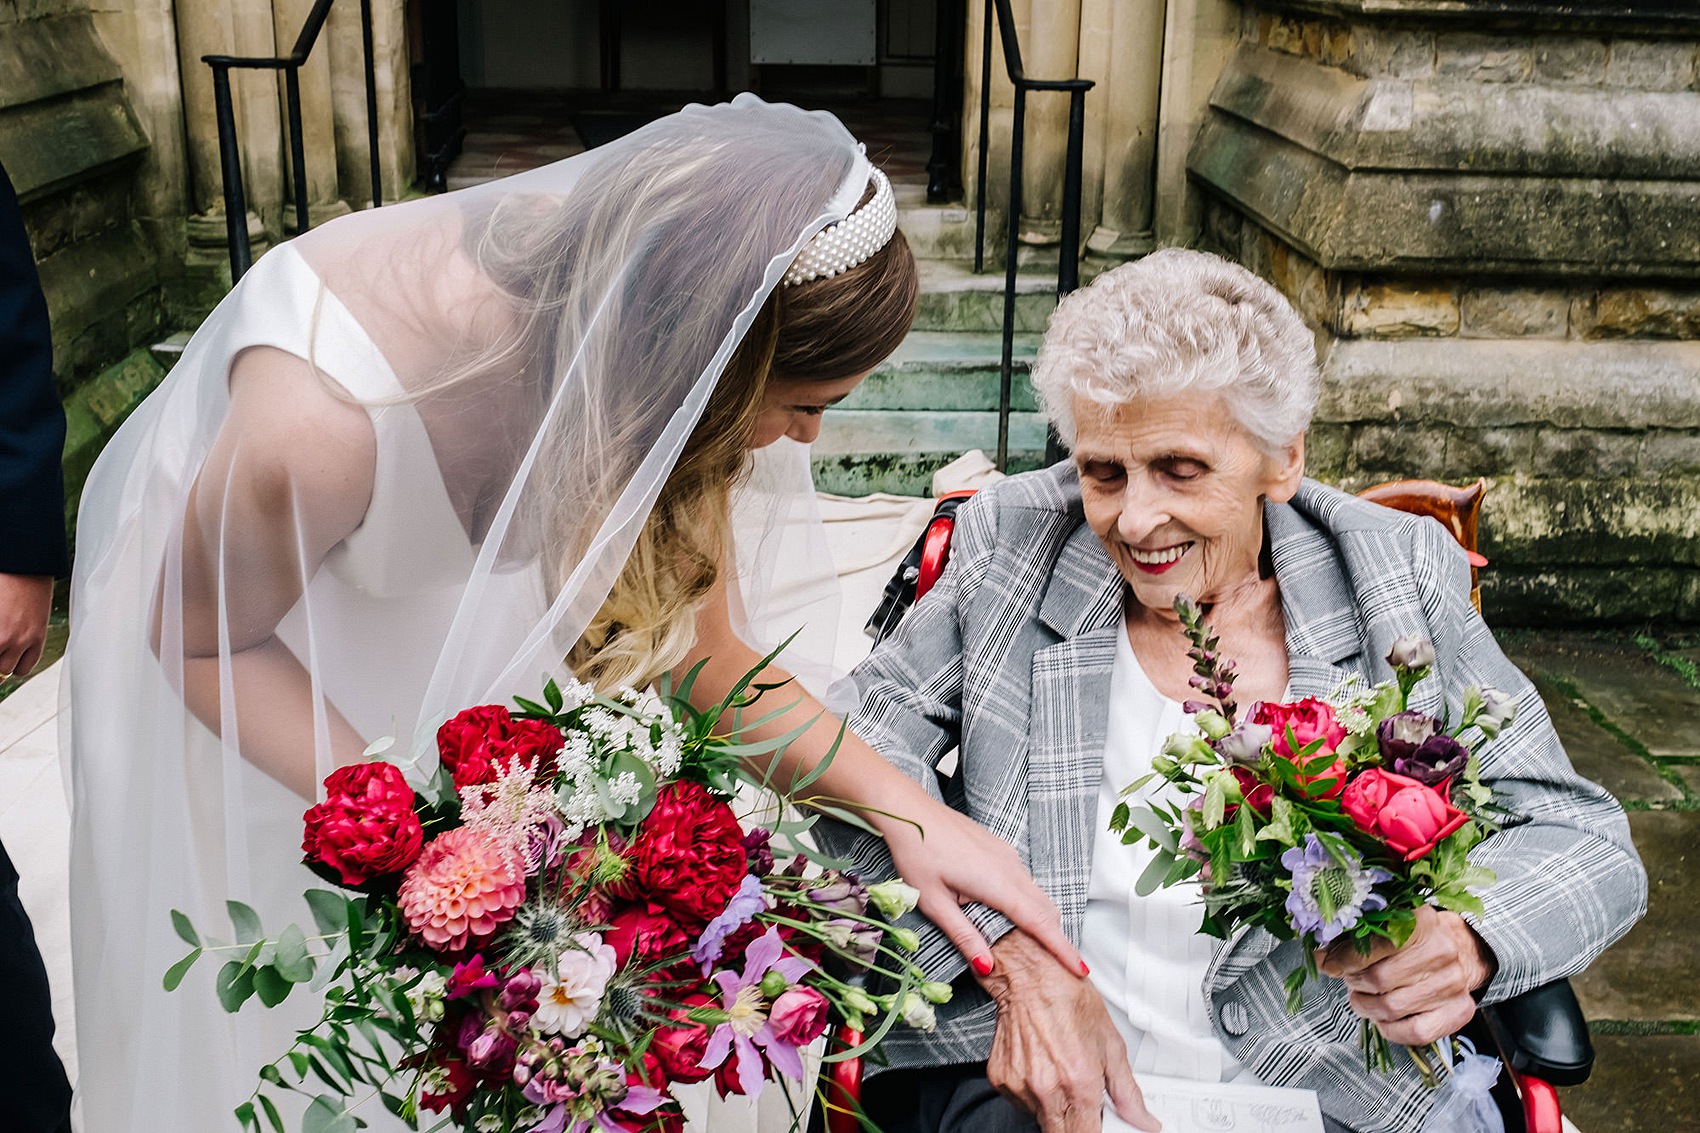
[610,783,750,932]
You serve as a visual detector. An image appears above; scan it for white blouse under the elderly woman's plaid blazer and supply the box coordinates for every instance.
[1081,633,1255,1082]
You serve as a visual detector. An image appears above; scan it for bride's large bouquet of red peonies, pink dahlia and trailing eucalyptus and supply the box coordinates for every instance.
[165,662,950,1133]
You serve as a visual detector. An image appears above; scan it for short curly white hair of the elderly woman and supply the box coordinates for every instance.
[1034,248,1319,453]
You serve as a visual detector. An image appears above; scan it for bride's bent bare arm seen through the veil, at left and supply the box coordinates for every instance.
[155,347,377,800]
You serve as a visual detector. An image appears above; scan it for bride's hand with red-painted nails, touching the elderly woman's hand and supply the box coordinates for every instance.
[870,796,1086,976]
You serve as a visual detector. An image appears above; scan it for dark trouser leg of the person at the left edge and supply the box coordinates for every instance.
[0,833,71,1133]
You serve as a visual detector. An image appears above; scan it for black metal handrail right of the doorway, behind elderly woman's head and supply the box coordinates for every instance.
[974,0,1093,468]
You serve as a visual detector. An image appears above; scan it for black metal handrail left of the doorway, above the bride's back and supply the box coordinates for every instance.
[201,0,384,282]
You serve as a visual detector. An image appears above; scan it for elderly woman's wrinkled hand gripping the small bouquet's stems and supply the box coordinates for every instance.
[1316,905,1499,1046]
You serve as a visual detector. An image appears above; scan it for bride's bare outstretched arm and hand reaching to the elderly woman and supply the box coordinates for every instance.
[683,582,1085,975]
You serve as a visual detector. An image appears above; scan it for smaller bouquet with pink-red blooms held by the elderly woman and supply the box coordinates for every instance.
[1110,595,1516,1085]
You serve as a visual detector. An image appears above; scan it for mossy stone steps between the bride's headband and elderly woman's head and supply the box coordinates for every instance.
[814,184,1056,495]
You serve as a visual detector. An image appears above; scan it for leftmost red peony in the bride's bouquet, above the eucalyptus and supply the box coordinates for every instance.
[301,762,425,885]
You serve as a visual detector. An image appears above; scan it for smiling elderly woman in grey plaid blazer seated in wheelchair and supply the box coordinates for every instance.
[826,250,1646,1133]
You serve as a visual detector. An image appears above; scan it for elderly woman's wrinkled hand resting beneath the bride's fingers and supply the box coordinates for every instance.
[981,929,1163,1133]
